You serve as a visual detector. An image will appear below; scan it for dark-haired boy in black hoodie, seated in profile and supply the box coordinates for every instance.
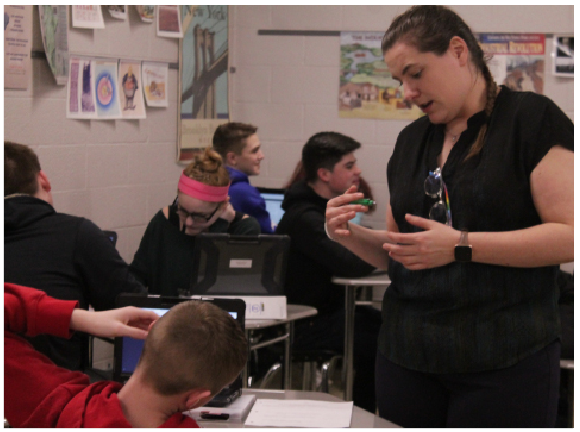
[276,132,381,413]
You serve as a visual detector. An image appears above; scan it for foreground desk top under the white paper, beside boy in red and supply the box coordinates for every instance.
[197,389,399,428]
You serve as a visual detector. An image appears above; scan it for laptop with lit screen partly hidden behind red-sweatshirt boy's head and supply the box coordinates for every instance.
[113,293,246,407]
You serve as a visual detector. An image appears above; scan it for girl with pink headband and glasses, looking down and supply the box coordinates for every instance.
[131,148,260,295]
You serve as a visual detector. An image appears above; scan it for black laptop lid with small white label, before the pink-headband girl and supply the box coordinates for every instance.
[189,233,290,296]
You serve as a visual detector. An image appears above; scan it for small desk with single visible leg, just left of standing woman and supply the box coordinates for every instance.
[332,274,391,401]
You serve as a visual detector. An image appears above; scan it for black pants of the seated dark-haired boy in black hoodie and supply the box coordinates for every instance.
[293,306,381,413]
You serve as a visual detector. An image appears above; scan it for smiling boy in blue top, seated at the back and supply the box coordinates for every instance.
[213,123,274,233]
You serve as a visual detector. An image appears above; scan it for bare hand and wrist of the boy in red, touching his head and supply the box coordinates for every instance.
[70,306,159,339]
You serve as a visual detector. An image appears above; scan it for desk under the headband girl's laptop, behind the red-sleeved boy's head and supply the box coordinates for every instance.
[242,304,317,389]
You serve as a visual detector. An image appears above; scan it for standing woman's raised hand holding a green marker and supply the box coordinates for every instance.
[326,185,367,239]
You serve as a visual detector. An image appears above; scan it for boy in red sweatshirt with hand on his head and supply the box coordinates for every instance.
[4,283,248,428]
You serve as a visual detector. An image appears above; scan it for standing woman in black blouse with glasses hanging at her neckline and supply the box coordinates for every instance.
[327,6,574,427]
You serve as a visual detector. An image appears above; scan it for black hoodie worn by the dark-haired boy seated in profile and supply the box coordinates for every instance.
[276,181,374,314]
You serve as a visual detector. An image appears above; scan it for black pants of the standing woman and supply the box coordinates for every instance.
[375,341,560,428]
